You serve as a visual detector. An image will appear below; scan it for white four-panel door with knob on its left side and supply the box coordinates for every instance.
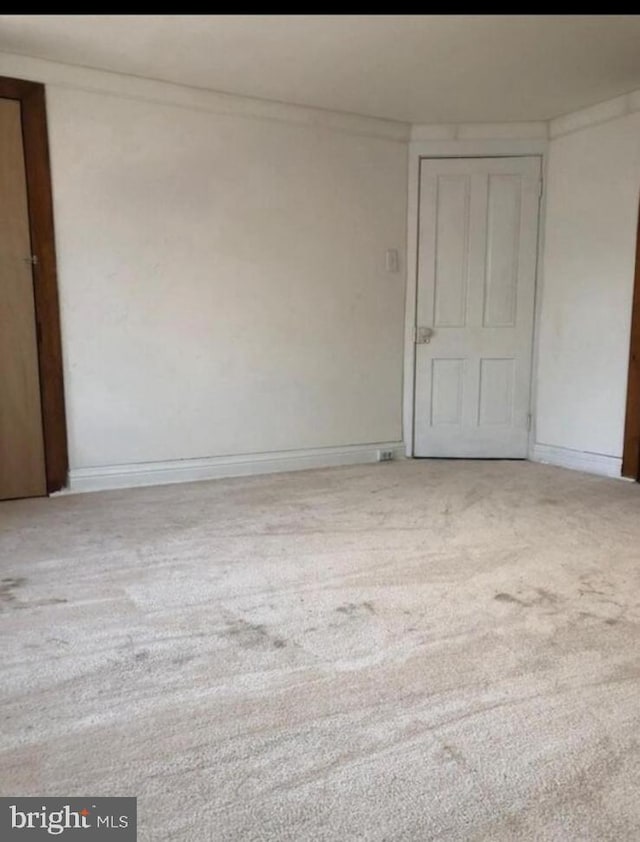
[414,157,541,459]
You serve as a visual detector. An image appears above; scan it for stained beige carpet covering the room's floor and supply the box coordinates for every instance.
[0,461,640,842]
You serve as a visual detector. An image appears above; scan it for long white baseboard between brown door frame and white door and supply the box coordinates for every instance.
[65,441,404,494]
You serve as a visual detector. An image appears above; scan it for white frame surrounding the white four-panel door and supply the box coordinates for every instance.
[402,135,548,458]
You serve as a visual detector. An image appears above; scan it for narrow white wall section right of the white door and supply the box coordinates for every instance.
[536,101,640,466]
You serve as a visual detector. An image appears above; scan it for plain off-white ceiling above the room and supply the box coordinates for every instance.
[0,15,640,123]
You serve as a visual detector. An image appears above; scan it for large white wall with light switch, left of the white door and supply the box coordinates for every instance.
[0,57,408,484]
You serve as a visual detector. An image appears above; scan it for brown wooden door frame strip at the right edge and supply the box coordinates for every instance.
[621,192,640,482]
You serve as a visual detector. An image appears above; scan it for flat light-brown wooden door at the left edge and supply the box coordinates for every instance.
[0,99,46,500]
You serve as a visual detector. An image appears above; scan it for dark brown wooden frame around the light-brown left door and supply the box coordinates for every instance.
[0,76,69,494]
